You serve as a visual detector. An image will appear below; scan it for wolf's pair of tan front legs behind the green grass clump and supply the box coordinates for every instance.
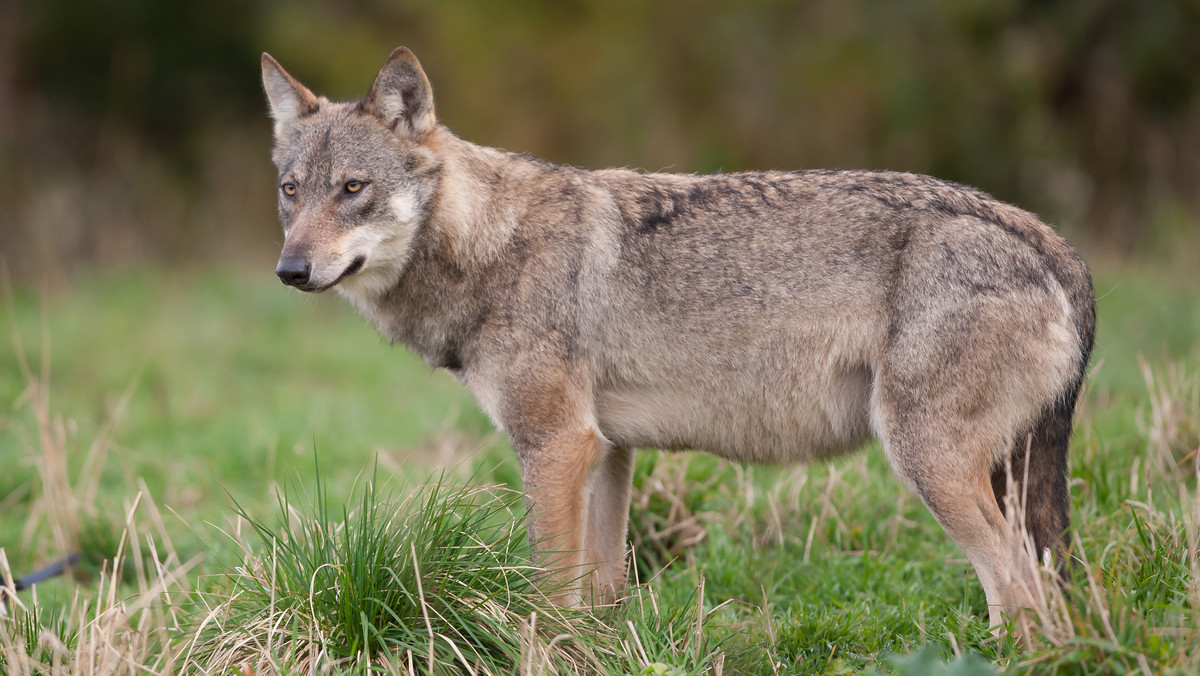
[480,355,634,605]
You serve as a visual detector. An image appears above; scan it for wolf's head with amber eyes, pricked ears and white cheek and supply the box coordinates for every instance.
[263,47,439,294]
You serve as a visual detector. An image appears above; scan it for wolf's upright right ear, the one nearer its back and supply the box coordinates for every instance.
[364,47,438,139]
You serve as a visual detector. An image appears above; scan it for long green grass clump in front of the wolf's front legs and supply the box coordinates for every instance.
[188,468,607,674]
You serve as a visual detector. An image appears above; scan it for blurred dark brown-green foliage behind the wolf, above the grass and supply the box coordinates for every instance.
[0,0,1200,287]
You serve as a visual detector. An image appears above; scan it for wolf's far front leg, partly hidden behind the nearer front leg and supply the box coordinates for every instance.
[583,447,635,605]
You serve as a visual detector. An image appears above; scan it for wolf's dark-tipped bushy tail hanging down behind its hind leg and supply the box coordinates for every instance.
[991,268,1096,575]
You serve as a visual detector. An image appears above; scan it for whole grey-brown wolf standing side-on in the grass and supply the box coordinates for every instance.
[263,47,1096,624]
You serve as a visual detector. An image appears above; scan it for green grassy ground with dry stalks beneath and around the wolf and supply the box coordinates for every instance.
[0,255,1200,674]
